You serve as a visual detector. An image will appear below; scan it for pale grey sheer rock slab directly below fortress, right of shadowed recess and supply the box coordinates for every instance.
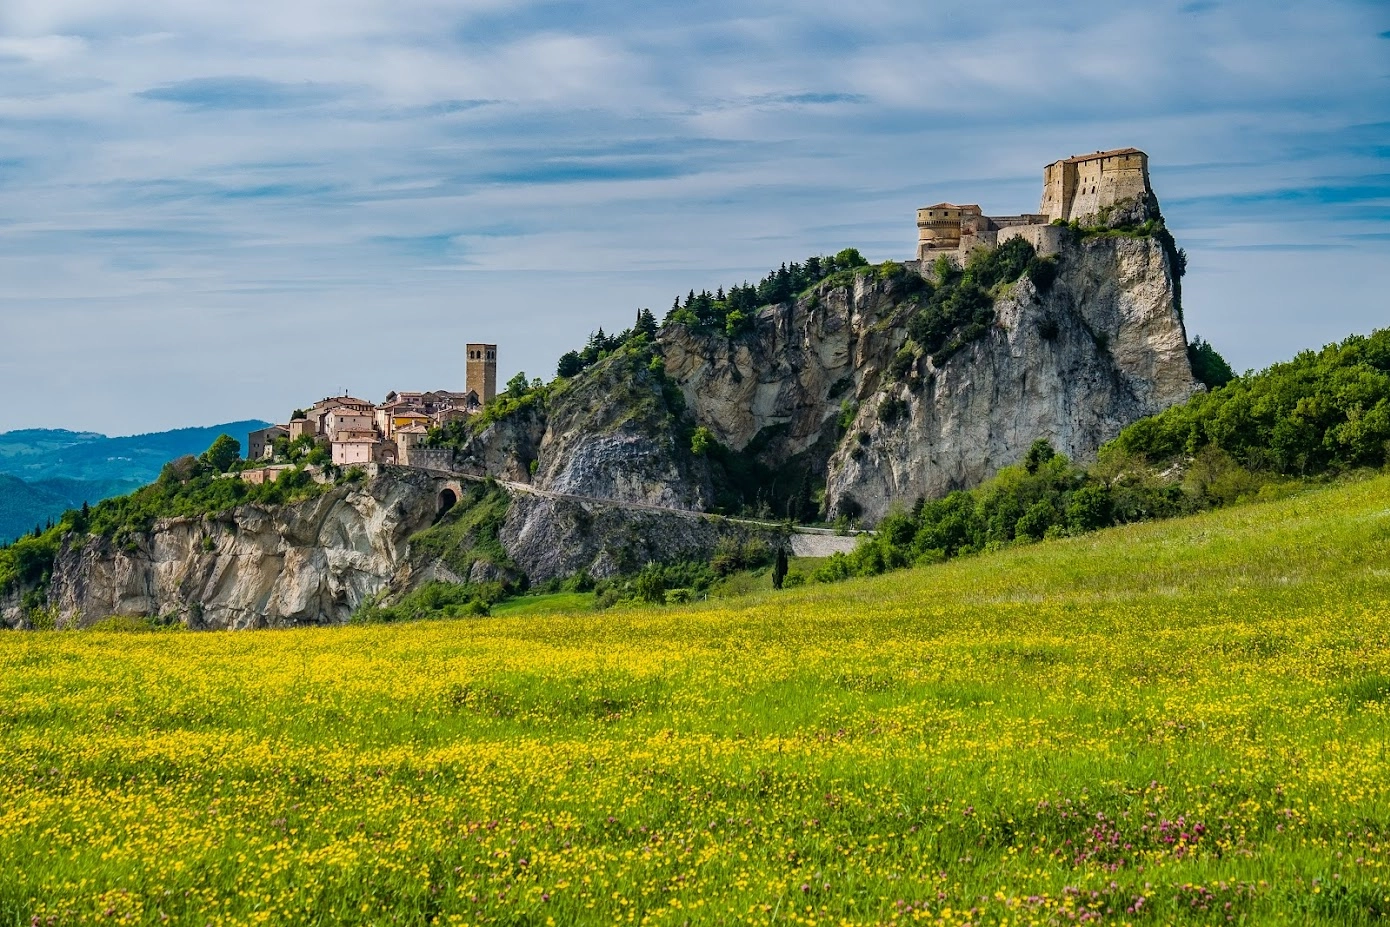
[826,238,1201,523]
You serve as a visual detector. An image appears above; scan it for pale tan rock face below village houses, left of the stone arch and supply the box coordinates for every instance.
[49,470,439,628]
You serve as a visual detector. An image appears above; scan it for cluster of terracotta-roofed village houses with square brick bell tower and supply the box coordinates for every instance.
[246,345,498,479]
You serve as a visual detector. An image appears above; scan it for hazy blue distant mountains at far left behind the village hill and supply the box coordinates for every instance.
[0,421,268,541]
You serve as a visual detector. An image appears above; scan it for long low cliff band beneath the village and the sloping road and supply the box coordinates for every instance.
[0,467,780,628]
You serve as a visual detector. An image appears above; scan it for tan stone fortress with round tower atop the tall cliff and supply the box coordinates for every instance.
[917,149,1154,261]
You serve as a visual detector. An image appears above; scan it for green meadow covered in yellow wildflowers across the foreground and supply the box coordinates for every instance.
[0,477,1390,926]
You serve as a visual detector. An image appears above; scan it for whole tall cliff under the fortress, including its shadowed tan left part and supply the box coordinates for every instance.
[662,222,1200,524]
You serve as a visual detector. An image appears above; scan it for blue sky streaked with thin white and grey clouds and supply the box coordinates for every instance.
[0,0,1390,434]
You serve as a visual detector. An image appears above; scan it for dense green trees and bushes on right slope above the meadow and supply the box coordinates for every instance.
[815,329,1390,581]
